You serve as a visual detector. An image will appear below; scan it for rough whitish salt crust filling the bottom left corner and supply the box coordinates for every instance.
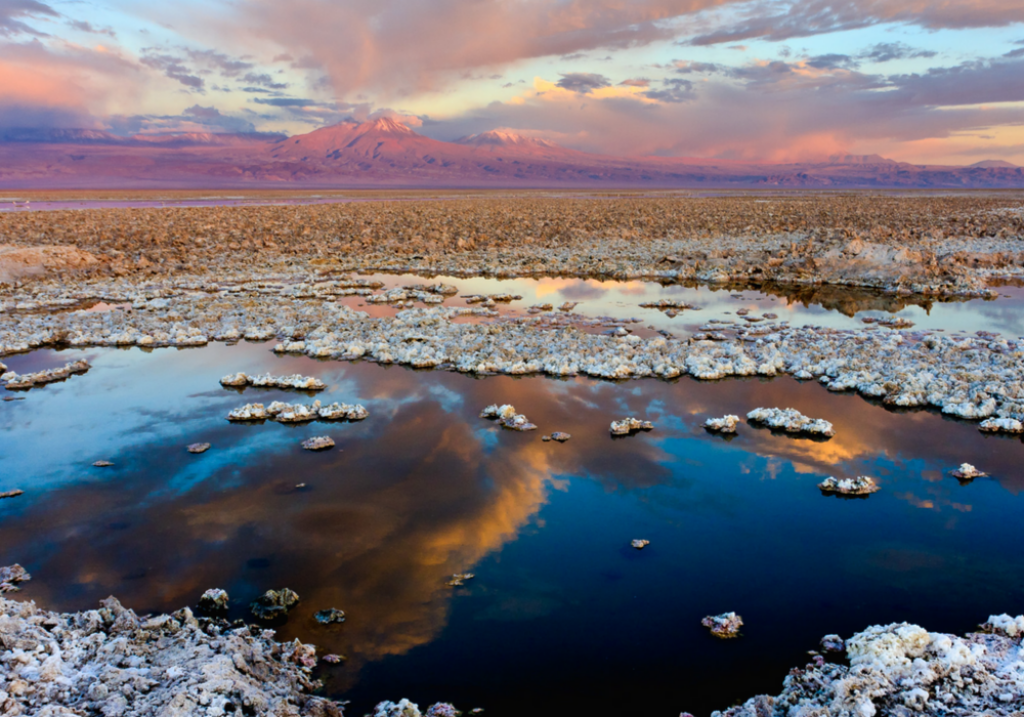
[0,597,342,717]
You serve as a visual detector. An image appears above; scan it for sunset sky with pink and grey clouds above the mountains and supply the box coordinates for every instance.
[6,0,1024,165]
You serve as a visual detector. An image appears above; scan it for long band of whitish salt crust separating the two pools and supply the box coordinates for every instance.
[6,282,1024,421]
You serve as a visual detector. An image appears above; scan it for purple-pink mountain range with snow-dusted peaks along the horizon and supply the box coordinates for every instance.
[0,117,1024,188]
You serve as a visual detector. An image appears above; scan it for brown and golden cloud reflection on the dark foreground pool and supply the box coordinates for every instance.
[0,352,1020,689]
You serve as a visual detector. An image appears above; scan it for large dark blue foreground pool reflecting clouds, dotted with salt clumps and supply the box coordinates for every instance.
[0,343,1024,717]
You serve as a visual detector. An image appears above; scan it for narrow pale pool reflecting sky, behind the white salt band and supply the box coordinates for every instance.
[344,273,1024,337]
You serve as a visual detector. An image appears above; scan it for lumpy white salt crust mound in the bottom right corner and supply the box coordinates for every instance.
[712,615,1024,717]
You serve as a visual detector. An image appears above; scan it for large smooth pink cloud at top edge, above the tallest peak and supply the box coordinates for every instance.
[232,0,740,100]
